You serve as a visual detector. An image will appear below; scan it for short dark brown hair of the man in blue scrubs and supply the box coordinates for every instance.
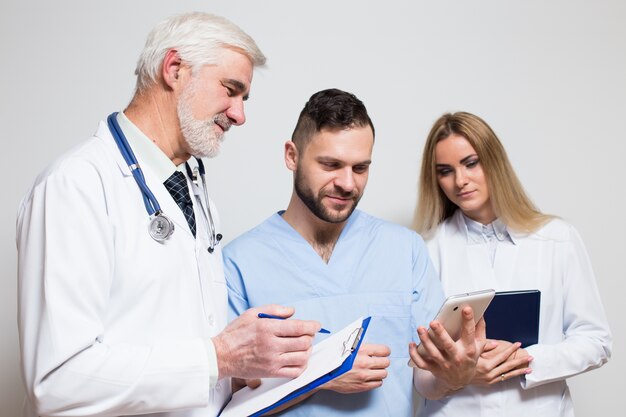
[291,88,375,151]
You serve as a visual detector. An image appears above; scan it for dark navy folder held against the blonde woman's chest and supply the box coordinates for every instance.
[484,290,541,348]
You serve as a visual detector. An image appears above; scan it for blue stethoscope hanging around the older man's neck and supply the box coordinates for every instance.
[107,112,222,253]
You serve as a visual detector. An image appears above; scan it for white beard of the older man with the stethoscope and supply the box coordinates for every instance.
[176,81,231,158]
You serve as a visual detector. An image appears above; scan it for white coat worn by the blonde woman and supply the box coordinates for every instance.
[414,210,611,417]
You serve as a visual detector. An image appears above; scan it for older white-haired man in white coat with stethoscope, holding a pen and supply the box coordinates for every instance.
[17,13,320,417]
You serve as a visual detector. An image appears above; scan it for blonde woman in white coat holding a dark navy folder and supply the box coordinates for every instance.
[411,112,611,417]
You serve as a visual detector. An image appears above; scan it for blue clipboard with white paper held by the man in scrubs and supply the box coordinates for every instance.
[220,317,371,417]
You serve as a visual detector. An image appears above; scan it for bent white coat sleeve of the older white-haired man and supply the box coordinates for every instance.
[17,160,217,417]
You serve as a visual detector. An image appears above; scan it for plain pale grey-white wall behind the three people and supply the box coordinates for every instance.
[0,0,626,417]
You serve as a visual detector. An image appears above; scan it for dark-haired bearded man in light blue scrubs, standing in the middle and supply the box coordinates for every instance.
[223,89,476,417]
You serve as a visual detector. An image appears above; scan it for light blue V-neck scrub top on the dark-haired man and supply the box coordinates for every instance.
[223,210,444,417]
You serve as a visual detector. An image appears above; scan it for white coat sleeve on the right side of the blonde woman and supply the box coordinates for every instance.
[521,226,612,389]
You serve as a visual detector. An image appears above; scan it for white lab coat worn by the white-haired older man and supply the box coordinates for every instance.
[17,122,230,417]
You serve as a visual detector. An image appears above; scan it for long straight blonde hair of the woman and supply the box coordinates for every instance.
[413,112,554,238]
